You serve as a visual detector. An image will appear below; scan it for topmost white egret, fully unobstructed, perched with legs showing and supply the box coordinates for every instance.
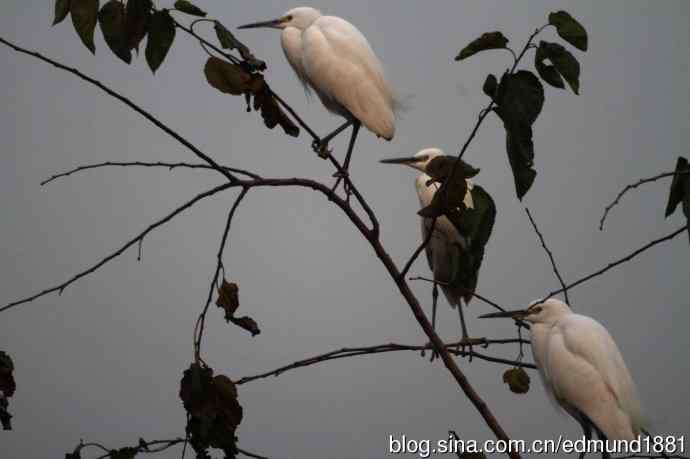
[239,7,398,175]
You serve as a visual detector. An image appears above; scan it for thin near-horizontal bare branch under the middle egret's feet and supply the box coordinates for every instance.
[235,338,536,385]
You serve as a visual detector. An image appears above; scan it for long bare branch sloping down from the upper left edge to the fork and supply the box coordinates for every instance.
[0,37,237,182]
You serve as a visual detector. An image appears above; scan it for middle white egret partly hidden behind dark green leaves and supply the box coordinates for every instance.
[381,148,496,341]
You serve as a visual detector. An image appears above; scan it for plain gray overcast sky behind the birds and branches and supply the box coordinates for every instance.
[0,0,690,458]
